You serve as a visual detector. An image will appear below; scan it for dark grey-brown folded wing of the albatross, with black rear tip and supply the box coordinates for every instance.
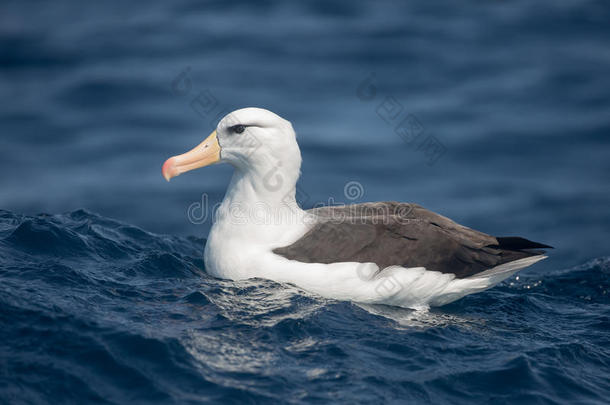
[273,202,550,278]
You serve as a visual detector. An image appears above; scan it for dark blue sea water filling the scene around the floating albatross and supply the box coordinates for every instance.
[0,0,610,403]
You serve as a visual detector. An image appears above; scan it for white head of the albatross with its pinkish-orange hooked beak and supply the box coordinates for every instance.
[163,108,301,197]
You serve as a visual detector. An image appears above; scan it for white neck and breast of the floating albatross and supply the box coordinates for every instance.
[204,152,309,278]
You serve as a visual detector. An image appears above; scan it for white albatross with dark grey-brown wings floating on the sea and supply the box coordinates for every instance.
[162,107,552,309]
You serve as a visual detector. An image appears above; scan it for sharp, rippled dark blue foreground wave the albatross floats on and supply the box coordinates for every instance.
[0,210,610,403]
